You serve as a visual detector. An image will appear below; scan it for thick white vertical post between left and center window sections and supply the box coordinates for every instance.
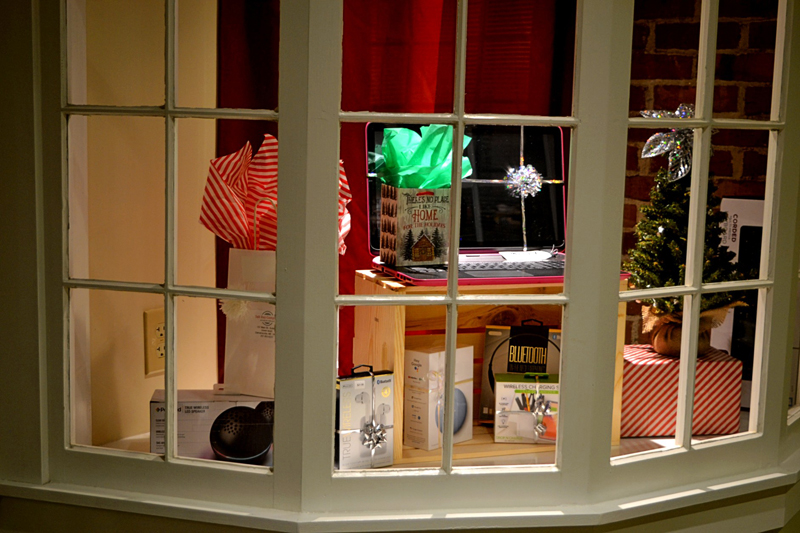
[274,0,343,510]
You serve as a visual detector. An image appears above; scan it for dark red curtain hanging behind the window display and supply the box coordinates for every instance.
[217,0,575,379]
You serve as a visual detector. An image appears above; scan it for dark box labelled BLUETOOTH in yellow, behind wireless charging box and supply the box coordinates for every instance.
[478,325,561,424]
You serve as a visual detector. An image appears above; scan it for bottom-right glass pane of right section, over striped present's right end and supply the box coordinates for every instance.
[692,290,761,440]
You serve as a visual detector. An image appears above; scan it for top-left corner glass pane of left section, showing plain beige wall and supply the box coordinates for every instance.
[67,0,165,106]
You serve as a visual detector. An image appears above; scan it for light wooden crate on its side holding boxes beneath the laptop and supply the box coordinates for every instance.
[353,270,627,465]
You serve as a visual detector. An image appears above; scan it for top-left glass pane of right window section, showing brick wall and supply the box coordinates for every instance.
[630,0,700,116]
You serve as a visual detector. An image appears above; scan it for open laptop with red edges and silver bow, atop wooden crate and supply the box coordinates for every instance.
[366,122,569,286]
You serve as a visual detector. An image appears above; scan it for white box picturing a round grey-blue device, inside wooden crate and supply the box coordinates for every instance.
[403,346,473,450]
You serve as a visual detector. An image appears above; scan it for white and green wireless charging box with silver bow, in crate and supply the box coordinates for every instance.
[494,374,558,444]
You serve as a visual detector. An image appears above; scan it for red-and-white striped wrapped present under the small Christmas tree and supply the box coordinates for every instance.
[620,344,742,437]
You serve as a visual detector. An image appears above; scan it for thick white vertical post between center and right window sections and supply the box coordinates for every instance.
[556,0,634,494]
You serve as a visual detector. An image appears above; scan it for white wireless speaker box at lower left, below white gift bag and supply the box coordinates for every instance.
[150,389,272,459]
